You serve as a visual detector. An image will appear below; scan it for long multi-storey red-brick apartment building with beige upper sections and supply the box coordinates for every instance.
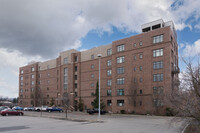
[19,19,179,114]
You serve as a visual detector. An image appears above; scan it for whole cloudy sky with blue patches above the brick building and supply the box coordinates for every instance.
[0,0,200,97]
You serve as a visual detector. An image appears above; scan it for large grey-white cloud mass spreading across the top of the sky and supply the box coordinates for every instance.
[0,0,200,58]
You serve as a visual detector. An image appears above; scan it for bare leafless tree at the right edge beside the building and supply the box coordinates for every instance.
[169,58,200,121]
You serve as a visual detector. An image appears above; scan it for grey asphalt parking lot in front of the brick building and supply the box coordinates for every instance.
[0,112,188,133]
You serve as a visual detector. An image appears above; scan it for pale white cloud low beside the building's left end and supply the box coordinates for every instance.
[0,48,43,97]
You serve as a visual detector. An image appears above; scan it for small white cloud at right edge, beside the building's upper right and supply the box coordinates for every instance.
[183,39,200,57]
